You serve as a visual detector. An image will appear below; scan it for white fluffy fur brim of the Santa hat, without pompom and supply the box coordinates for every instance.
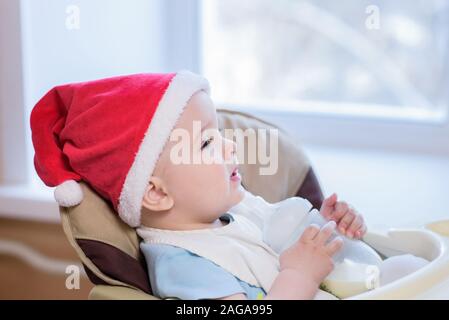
[118,71,210,227]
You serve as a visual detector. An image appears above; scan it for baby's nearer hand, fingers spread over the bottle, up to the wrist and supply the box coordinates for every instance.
[279,221,343,286]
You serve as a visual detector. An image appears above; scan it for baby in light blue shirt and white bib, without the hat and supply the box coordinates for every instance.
[137,87,366,299]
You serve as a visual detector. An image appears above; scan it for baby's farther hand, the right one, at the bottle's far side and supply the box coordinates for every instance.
[320,193,367,239]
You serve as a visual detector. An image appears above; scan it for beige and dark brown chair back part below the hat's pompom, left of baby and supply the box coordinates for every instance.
[60,182,146,293]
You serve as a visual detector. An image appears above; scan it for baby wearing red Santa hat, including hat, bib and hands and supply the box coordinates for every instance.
[31,71,428,299]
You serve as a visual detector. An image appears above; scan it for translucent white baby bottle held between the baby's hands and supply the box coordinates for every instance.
[231,192,382,298]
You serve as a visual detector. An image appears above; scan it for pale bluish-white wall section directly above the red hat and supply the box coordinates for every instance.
[21,0,170,185]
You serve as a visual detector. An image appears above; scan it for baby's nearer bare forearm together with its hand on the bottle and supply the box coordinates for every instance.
[219,221,343,300]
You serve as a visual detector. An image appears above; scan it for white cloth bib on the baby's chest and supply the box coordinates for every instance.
[137,214,279,292]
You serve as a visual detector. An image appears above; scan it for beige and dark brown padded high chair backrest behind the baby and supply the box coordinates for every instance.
[60,110,322,293]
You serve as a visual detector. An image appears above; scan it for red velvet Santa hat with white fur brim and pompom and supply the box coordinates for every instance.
[30,71,209,227]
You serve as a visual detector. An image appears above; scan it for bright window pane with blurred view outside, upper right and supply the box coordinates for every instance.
[202,0,449,120]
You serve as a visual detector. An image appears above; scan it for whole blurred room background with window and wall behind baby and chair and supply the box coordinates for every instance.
[0,0,449,299]
